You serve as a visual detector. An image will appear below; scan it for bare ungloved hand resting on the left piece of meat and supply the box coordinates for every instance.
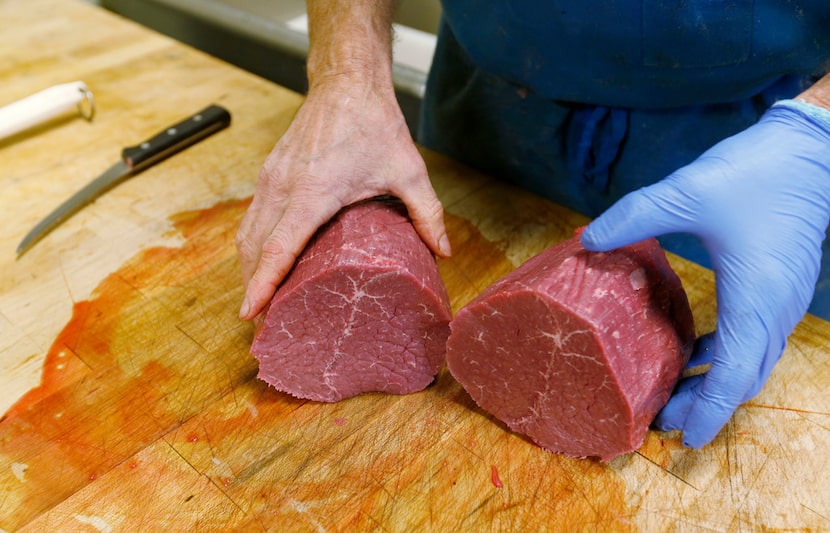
[236,81,450,320]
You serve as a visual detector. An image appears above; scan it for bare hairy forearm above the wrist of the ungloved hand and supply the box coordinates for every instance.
[307,0,395,91]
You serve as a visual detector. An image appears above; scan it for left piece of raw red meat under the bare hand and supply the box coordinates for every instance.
[251,199,451,402]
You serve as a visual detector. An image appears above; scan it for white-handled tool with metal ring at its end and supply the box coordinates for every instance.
[0,81,95,139]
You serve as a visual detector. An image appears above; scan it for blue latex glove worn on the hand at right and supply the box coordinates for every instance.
[582,101,830,448]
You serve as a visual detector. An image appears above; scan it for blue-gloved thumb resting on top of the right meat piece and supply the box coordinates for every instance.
[582,177,697,252]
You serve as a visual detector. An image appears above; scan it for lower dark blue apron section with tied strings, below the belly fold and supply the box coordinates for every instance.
[419,18,830,319]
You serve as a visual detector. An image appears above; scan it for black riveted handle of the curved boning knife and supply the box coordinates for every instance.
[121,105,231,171]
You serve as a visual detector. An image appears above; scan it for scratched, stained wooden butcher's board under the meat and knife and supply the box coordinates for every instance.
[0,0,830,531]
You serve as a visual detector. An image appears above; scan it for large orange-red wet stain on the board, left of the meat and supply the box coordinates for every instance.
[0,200,255,530]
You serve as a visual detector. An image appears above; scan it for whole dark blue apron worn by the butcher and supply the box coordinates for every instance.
[419,0,830,320]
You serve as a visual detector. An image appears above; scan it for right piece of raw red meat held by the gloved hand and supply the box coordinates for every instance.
[447,232,695,461]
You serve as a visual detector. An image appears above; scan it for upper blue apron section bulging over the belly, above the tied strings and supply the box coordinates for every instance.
[443,0,830,108]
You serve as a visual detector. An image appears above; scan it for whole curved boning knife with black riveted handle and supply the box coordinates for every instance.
[17,105,231,259]
